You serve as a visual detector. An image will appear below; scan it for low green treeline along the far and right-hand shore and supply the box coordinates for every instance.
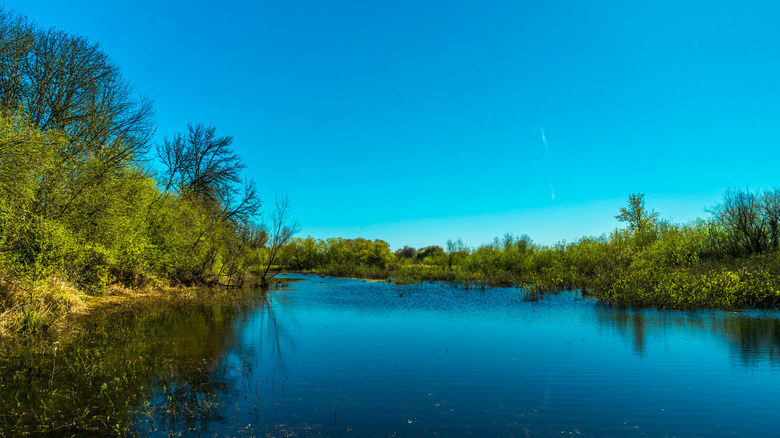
[282,189,780,309]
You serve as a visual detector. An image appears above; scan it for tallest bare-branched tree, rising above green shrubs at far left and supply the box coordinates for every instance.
[0,6,154,221]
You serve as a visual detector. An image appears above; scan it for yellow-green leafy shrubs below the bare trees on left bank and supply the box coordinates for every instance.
[0,109,266,300]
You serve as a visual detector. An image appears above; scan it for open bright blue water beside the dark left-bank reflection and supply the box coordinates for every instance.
[137,275,780,437]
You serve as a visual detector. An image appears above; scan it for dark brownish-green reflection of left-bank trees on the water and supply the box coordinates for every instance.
[0,292,292,436]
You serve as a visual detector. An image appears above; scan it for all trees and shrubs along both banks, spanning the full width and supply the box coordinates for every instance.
[0,10,780,318]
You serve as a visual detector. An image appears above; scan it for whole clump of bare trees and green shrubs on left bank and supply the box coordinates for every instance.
[0,9,295,332]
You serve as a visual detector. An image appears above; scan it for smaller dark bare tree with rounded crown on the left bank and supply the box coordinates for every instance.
[152,123,262,283]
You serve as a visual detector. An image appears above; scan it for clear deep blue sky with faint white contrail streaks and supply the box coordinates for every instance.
[5,0,780,249]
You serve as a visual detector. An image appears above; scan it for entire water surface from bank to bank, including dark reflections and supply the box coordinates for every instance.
[0,277,780,436]
